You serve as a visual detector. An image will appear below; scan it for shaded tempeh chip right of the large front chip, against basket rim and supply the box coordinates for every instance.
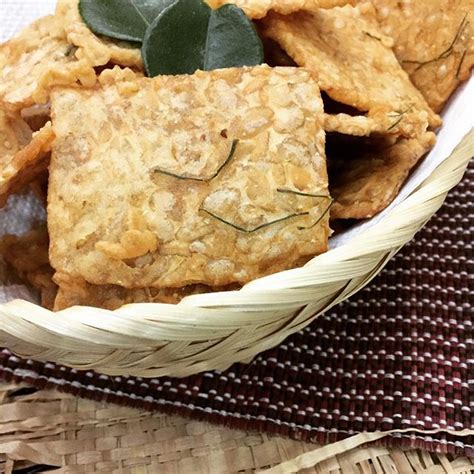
[328,132,436,219]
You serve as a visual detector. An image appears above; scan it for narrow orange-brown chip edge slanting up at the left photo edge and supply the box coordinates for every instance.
[0,123,54,208]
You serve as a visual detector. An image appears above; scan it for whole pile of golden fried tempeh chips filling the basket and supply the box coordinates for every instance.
[0,0,474,309]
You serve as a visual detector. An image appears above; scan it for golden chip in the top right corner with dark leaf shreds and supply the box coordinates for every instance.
[372,0,474,112]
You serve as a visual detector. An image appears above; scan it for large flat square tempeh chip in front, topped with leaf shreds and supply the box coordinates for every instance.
[48,66,330,288]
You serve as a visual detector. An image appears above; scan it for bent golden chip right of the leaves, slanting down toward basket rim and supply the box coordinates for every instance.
[262,3,441,137]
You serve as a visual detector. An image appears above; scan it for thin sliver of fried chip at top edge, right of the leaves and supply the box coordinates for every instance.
[206,0,355,20]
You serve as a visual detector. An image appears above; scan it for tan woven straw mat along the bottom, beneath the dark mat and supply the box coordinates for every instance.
[0,385,474,474]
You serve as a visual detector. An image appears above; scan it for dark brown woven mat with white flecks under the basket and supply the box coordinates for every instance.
[0,166,474,456]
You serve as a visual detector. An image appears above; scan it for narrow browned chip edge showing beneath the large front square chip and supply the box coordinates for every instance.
[54,274,236,311]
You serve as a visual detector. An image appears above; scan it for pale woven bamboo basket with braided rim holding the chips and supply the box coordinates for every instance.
[0,129,474,377]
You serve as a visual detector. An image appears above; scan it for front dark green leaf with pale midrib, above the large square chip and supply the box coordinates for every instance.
[142,0,264,77]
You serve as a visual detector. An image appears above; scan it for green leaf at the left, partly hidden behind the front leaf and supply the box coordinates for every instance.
[79,0,176,43]
